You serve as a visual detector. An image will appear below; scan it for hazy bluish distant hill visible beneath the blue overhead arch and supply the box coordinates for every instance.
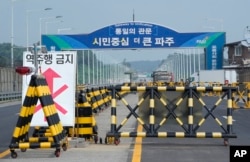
[129,60,161,73]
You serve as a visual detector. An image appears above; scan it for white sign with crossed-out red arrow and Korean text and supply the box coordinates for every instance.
[22,51,76,126]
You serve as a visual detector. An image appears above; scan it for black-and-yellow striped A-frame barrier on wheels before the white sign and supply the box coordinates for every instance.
[9,75,68,158]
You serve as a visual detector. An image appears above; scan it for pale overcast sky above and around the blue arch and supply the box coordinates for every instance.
[0,0,250,60]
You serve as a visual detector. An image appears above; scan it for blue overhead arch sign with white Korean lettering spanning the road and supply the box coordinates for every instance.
[42,22,225,69]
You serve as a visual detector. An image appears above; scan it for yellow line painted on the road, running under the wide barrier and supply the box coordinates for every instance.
[132,125,142,162]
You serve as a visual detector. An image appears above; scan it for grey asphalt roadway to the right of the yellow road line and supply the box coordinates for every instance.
[141,97,250,162]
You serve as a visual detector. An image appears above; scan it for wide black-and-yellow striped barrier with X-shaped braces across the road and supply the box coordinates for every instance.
[105,86,237,145]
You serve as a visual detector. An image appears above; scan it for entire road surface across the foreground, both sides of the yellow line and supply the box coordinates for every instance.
[0,94,250,162]
